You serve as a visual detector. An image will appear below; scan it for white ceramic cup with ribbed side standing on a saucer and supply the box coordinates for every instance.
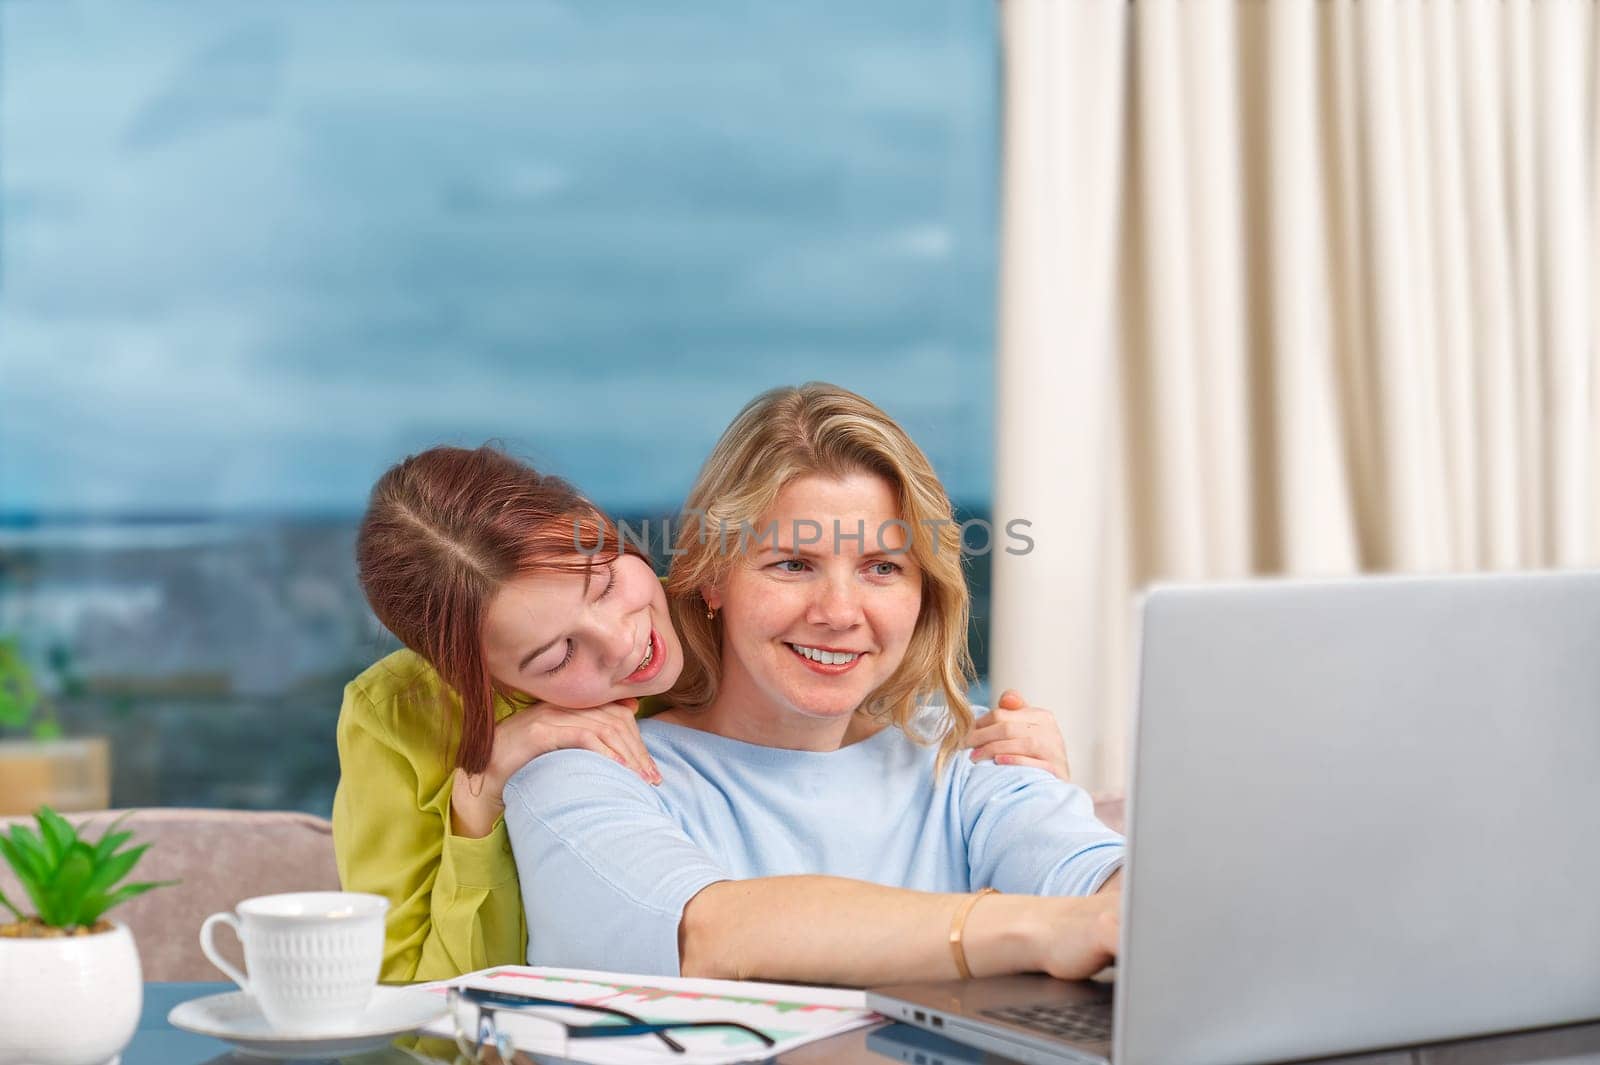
[200,891,389,1035]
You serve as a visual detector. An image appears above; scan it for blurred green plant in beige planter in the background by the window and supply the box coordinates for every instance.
[0,636,110,814]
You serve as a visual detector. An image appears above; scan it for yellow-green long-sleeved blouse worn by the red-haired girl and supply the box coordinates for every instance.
[333,651,528,983]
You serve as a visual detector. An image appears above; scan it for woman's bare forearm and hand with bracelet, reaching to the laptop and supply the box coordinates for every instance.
[680,876,1120,987]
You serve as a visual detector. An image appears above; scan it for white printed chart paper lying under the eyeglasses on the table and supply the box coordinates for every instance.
[421,966,878,1065]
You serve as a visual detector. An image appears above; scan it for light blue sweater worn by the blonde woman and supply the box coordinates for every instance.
[506,720,1123,975]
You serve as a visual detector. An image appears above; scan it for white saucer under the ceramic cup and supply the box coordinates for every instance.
[166,987,448,1057]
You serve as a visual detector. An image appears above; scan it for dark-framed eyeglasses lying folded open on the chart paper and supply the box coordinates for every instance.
[448,987,776,1062]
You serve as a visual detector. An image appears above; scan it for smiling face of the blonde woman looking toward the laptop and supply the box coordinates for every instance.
[704,473,922,728]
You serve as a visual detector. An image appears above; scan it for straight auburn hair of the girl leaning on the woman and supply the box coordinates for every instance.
[355,446,640,774]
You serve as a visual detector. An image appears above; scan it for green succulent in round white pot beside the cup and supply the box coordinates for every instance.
[0,806,174,1065]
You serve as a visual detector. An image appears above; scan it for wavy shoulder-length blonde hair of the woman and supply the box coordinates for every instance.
[667,382,973,766]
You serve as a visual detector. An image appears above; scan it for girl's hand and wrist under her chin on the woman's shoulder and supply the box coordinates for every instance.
[450,699,661,838]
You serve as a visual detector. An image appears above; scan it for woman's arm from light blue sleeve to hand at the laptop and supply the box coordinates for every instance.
[506,741,1117,985]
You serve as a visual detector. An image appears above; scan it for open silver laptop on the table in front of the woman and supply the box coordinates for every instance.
[867,572,1600,1065]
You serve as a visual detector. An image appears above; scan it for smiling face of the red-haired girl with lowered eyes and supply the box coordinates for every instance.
[483,555,683,710]
